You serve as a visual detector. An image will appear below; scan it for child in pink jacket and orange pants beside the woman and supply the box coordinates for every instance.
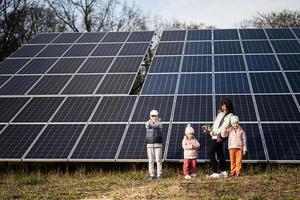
[222,116,247,176]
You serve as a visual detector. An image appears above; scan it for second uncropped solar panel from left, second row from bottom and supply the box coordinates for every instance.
[52,97,100,122]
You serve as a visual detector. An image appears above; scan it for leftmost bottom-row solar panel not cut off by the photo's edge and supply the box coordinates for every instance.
[25,124,84,159]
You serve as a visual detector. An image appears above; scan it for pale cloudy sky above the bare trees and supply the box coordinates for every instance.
[129,0,300,28]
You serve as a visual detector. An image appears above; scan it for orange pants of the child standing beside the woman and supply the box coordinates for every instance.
[229,149,243,176]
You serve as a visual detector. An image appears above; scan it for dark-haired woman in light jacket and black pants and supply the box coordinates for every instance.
[209,98,233,178]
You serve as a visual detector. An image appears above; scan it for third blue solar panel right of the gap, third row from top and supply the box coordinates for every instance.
[214,55,246,72]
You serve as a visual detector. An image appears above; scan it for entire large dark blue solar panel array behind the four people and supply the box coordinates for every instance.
[0,28,300,162]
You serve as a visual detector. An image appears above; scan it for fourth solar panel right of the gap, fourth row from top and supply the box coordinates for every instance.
[250,73,289,93]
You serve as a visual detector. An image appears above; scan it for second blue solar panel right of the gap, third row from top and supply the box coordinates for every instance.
[181,56,212,72]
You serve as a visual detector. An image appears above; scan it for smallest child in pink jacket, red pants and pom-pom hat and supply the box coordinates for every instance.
[182,124,200,179]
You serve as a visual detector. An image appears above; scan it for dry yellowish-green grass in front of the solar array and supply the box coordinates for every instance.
[0,165,300,200]
